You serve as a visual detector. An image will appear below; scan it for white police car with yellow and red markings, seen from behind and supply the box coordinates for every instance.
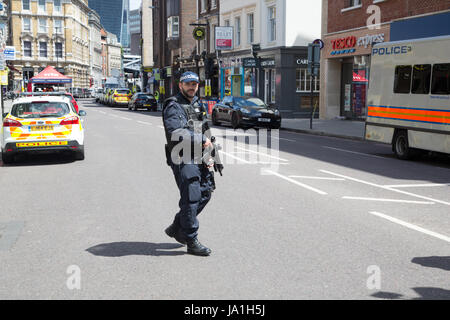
[1,94,86,164]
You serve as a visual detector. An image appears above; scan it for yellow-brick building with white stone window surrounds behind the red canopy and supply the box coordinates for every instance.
[11,0,90,88]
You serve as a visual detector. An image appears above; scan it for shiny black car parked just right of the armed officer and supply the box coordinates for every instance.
[211,96,281,129]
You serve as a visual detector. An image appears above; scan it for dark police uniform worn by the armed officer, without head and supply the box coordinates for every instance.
[163,93,215,245]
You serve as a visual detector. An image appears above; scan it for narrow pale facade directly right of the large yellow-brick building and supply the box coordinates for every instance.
[89,10,103,88]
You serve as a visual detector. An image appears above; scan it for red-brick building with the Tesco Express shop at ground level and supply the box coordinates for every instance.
[320,0,450,119]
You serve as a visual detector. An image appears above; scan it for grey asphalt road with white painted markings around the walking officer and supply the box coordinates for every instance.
[0,101,450,300]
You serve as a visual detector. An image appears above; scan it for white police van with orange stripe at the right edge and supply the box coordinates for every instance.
[365,36,450,159]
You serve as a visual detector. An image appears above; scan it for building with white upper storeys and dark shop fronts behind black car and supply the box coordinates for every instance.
[220,0,321,118]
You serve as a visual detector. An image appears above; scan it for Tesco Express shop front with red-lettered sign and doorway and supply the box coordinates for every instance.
[320,25,390,119]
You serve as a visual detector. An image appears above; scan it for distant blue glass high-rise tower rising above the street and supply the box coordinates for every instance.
[89,0,130,48]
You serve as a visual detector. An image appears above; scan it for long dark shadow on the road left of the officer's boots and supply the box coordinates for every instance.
[86,242,186,257]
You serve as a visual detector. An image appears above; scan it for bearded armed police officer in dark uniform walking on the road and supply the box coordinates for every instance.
[163,72,215,256]
